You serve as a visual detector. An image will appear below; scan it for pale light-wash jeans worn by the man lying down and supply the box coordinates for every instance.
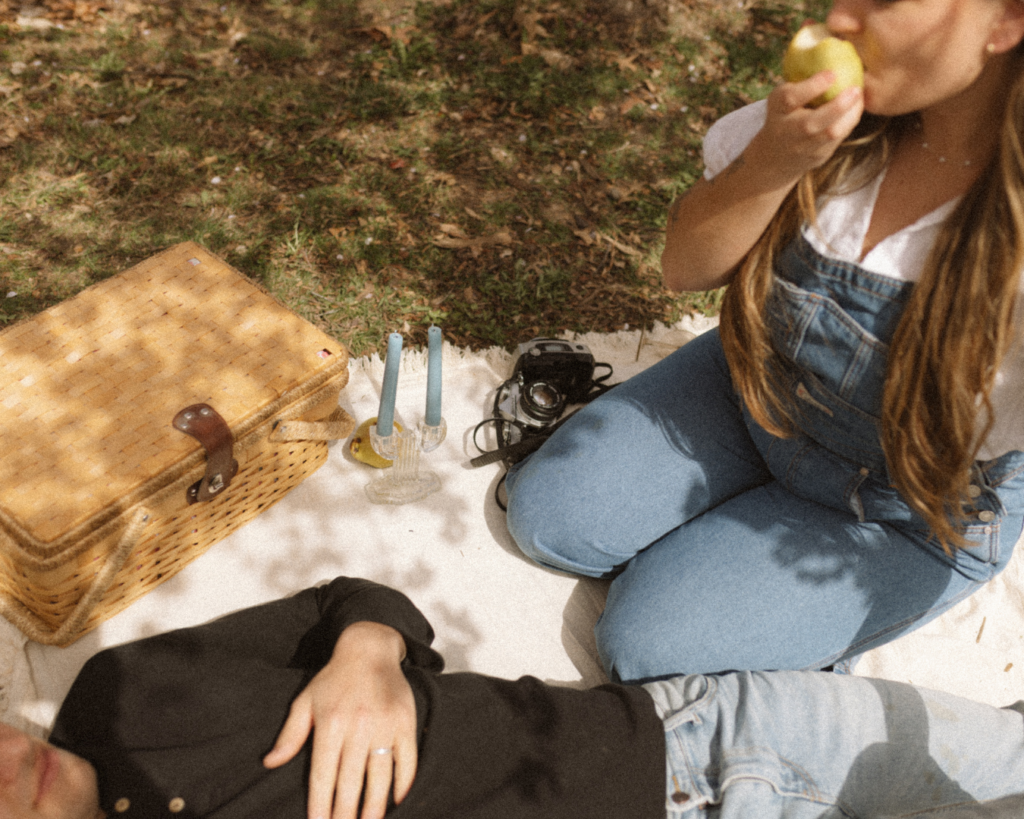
[644,672,1024,819]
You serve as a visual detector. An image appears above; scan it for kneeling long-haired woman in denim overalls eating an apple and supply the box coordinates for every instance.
[508,0,1024,681]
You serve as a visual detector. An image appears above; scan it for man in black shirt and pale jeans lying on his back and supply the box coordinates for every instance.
[6,577,1024,819]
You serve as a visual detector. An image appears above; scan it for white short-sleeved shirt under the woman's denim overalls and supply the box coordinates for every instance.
[703,99,1024,460]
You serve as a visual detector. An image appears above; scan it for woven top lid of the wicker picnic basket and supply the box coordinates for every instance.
[0,242,347,544]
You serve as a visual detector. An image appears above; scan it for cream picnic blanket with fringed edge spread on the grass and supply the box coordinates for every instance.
[0,319,1024,733]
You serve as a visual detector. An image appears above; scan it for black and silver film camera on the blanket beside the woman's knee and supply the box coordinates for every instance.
[498,338,595,437]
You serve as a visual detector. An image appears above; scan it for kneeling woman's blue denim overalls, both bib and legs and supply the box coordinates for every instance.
[506,241,1024,682]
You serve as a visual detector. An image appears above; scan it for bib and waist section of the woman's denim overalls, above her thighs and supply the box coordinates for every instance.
[750,238,1024,583]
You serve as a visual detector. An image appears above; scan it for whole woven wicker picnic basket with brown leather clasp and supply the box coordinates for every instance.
[0,243,352,645]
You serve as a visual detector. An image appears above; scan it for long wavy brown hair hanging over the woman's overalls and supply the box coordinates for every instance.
[720,46,1024,552]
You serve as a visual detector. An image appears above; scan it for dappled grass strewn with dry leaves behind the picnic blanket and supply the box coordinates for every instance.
[0,0,825,355]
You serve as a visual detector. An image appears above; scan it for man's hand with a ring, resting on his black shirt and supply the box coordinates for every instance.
[263,622,417,819]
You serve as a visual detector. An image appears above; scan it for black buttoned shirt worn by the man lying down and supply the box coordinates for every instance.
[50,577,665,819]
